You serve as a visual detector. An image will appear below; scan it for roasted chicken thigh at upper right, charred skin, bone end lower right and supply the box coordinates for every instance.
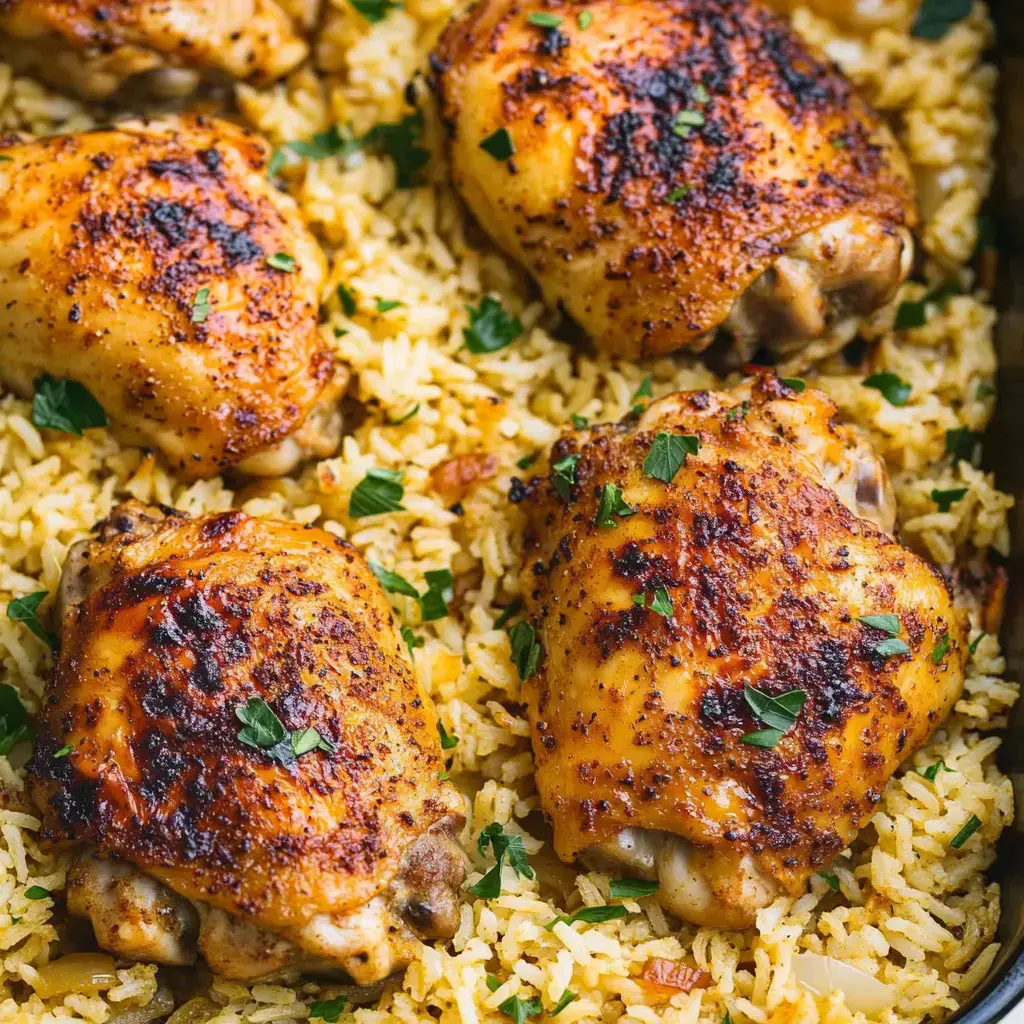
[433,0,916,356]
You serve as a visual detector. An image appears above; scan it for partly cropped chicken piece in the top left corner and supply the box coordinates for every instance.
[0,0,308,99]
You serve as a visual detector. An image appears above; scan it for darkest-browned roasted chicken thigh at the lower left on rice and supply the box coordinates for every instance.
[29,503,465,984]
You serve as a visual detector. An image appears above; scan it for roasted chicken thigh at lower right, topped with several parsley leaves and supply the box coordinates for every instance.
[513,376,965,928]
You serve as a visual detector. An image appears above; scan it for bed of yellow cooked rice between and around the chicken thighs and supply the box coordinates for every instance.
[0,0,1017,1024]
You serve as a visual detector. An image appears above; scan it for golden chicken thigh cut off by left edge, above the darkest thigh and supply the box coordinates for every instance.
[0,118,344,477]
